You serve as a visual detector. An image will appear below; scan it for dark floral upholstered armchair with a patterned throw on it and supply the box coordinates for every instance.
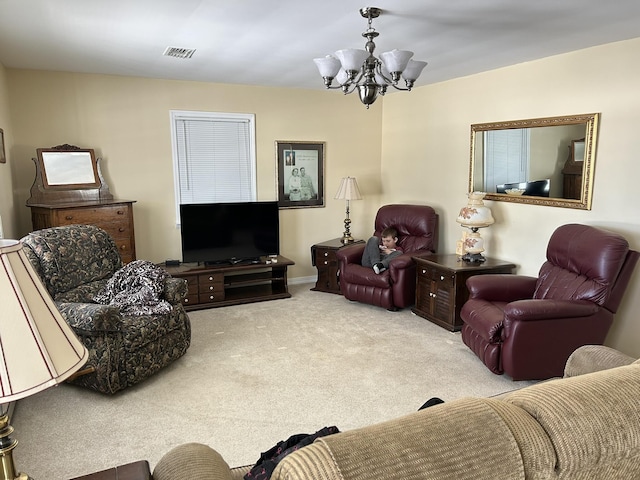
[21,225,191,394]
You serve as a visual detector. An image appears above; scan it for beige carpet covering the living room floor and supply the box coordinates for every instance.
[13,284,530,480]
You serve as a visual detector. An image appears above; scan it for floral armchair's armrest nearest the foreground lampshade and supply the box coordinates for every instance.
[56,302,121,335]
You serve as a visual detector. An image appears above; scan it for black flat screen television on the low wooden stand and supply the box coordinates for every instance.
[180,202,280,265]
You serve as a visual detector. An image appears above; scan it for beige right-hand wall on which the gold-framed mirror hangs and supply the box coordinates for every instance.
[382,39,640,356]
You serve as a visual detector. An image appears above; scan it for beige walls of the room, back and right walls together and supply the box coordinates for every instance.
[5,39,640,356]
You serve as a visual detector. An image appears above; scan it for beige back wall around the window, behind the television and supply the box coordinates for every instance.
[8,69,382,277]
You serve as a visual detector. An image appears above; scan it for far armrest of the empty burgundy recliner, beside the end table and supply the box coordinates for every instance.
[467,273,538,302]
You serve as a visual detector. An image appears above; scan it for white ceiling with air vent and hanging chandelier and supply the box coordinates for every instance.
[0,0,640,89]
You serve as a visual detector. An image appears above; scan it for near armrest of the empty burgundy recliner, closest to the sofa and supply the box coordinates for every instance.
[504,298,600,323]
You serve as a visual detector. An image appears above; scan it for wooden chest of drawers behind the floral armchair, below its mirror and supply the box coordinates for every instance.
[30,200,136,263]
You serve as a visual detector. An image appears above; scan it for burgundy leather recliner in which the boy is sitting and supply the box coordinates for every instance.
[337,204,438,310]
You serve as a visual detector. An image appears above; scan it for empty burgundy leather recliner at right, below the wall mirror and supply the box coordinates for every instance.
[460,224,640,380]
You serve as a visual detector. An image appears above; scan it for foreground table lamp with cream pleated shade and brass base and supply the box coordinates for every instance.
[0,239,89,480]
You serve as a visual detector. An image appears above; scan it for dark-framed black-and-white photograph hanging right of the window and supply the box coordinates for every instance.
[276,140,325,208]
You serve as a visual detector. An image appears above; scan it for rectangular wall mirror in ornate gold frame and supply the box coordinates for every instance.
[469,113,600,210]
